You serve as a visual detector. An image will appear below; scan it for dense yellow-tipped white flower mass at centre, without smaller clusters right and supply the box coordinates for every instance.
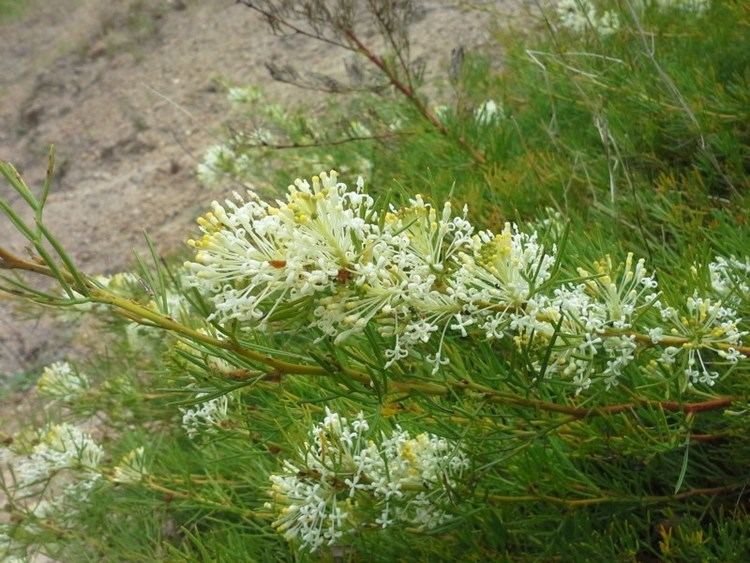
[186,172,555,369]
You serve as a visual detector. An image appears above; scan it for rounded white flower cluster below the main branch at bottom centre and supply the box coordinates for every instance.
[266,408,469,551]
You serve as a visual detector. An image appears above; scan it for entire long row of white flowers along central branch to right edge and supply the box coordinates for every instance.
[186,172,744,392]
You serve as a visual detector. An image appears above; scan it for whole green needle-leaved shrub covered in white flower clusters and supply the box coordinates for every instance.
[0,0,750,561]
